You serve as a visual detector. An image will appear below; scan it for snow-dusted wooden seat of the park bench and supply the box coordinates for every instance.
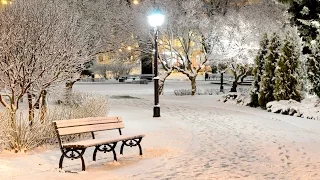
[62,134,145,148]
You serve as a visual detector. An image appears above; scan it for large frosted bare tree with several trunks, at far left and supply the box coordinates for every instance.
[0,0,93,126]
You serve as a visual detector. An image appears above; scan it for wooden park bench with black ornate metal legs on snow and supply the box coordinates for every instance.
[53,117,144,171]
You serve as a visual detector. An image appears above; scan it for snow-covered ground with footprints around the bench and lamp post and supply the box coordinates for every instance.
[0,81,320,180]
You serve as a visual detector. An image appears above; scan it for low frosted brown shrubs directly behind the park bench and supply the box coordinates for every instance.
[0,94,109,152]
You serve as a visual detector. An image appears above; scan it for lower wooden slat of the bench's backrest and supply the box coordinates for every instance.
[58,122,124,135]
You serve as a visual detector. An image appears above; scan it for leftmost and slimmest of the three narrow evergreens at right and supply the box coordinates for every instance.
[250,34,269,107]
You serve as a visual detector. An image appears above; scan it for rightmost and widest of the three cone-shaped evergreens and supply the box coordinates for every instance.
[274,36,301,101]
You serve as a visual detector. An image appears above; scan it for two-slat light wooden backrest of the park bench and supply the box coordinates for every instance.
[53,116,124,136]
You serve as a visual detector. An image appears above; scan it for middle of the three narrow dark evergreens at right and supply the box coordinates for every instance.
[259,33,281,108]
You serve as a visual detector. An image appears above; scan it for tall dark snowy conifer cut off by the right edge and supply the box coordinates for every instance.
[279,0,320,97]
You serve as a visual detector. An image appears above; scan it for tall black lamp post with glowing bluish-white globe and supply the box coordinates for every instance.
[148,8,164,117]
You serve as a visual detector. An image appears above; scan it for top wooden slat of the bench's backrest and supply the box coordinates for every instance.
[54,117,122,128]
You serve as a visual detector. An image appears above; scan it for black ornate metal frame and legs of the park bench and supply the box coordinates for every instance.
[53,117,144,171]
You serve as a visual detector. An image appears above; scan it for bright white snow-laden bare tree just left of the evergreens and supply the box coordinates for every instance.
[205,0,288,92]
